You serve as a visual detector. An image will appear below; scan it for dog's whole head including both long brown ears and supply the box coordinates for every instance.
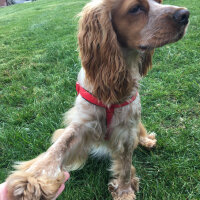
[78,0,189,103]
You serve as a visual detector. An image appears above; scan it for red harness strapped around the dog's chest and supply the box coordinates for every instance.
[76,82,138,140]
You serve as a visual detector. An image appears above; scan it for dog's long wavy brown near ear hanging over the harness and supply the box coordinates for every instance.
[78,3,132,103]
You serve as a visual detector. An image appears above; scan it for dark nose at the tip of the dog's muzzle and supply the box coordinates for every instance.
[173,8,190,25]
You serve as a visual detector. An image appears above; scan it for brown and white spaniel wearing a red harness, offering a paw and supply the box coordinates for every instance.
[7,0,189,200]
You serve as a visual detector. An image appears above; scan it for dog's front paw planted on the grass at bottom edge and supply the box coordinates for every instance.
[108,179,136,200]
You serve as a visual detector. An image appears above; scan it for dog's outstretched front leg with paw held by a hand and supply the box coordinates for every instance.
[6,124,92,200]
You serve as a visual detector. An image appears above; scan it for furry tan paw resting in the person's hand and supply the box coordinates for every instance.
[6,171,63,200]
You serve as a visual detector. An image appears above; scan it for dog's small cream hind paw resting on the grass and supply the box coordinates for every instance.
[139,132,157,149]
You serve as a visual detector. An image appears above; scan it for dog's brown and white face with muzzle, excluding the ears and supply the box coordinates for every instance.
[112,0,189,50]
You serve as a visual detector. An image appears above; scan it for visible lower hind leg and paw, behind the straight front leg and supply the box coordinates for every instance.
[139,122,157,148]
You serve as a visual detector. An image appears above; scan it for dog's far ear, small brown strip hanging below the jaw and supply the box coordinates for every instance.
[140,50,154,76]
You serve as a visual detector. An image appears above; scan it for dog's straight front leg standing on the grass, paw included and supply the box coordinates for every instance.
[108,135,139,200]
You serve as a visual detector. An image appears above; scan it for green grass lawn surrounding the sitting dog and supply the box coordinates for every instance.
[0,0,200,200]
